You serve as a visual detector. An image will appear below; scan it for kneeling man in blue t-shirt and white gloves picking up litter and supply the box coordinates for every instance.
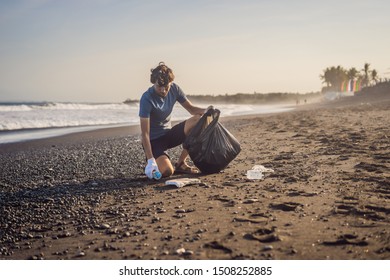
[139,62,212,179]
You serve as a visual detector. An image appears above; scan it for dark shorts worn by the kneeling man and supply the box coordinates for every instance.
[150,121,186,159]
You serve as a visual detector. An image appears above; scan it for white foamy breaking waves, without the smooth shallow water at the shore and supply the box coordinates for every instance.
[0,102,290,131]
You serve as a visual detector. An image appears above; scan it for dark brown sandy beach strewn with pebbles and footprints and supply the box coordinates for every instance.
[0,94,390,260]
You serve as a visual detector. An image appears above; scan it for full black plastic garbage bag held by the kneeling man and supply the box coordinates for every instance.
[183,109,241,174]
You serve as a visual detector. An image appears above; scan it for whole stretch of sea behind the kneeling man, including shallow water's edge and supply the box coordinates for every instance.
[0,102,293,144]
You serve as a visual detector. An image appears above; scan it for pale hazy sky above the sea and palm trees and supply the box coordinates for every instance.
[0,0,390,102]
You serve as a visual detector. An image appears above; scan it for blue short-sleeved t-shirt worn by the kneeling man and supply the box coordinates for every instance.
[139,83,187,140]
